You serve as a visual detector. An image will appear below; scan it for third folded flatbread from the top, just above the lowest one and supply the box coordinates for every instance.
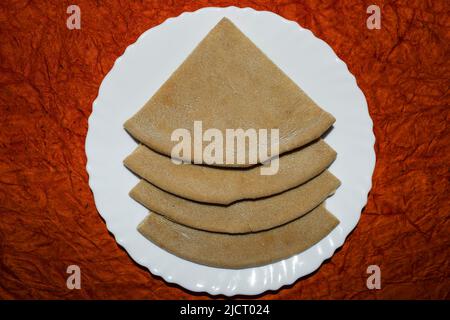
[130,170,340,234]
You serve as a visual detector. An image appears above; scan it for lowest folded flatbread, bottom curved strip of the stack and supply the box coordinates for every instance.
[138,205,339,269]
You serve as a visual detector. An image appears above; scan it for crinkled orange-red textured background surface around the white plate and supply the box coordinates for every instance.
[0,0,450,299]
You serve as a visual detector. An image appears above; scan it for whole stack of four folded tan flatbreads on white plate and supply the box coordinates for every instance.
[124,18,340,268]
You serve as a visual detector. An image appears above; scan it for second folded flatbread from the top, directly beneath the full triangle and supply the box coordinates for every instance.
[124,140,336,204]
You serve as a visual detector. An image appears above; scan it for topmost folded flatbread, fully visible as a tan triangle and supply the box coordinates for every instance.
[125,18,335,167]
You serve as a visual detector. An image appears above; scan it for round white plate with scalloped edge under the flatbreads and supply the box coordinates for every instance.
[86,7,375,296]
